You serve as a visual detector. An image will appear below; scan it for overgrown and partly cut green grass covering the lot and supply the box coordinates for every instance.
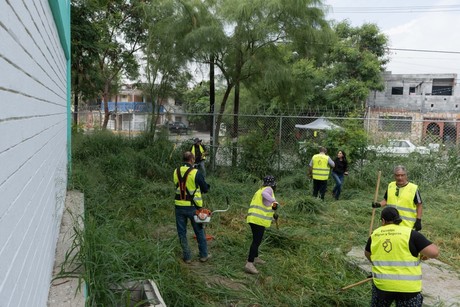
[65,133,460,306]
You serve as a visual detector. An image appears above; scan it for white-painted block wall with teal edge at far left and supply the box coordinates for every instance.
[0,0,70,307]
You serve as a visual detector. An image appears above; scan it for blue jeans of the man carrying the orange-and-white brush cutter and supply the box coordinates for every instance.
[175,206,208,261]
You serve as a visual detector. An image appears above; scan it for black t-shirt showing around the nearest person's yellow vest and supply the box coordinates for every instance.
[365,230,432,300]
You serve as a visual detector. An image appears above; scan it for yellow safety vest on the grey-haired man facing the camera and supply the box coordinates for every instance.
[387,181,417,229]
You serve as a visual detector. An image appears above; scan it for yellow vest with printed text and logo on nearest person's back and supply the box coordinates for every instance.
[371,224,422,293]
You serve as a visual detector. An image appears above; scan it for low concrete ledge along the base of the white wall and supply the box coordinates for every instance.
[47,191,85,307]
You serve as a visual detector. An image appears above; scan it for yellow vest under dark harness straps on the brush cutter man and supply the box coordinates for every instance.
[174,165,203,207]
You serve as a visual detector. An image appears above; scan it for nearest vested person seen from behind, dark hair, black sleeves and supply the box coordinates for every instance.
[364,207,439,307]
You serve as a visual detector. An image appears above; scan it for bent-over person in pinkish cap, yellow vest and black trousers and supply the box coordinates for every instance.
[244,175,279,274]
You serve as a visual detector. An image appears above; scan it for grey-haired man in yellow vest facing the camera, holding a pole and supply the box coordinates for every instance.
[372,165,423,231]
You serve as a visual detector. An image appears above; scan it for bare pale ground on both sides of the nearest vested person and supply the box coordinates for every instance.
[347,246,460,307]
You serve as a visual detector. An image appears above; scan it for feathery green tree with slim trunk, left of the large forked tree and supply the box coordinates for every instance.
[143,0,199,132]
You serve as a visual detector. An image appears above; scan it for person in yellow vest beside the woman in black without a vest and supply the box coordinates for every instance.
[308,147,335,200]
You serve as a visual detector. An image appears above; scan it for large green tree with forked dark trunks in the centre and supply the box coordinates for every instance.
[192,0,328,164]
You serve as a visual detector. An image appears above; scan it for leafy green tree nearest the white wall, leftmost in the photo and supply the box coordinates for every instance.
[71,0,145,128]
